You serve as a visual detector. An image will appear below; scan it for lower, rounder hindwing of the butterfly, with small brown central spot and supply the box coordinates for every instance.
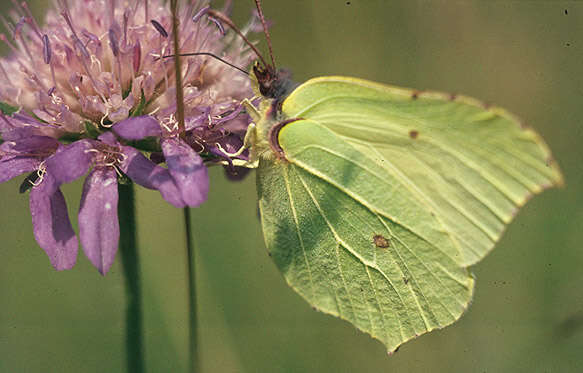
[258,121,473,351]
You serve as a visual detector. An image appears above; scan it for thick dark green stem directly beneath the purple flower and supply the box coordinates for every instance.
[118,184,145,373]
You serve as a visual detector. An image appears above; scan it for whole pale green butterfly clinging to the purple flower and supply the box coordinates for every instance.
[213,0,563,352]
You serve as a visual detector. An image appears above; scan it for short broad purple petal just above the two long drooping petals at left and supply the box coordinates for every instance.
[46,140,93,185]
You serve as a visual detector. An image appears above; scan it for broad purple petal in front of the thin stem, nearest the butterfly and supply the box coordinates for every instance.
[161,138,209,207]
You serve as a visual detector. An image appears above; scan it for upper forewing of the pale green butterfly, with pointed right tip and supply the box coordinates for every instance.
[283,77,562,266]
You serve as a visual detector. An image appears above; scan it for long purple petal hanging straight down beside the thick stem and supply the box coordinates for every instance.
[79,167,119,275]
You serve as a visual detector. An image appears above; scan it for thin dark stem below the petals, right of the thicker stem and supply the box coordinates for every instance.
[184,207,200,373]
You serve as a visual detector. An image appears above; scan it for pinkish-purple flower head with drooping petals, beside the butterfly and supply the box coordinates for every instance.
[0,0,257,274]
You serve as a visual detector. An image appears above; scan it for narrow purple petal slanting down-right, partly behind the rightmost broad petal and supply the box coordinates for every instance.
[120,146,186,207]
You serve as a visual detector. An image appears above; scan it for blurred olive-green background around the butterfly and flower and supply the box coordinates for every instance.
[0,0,583,373]
